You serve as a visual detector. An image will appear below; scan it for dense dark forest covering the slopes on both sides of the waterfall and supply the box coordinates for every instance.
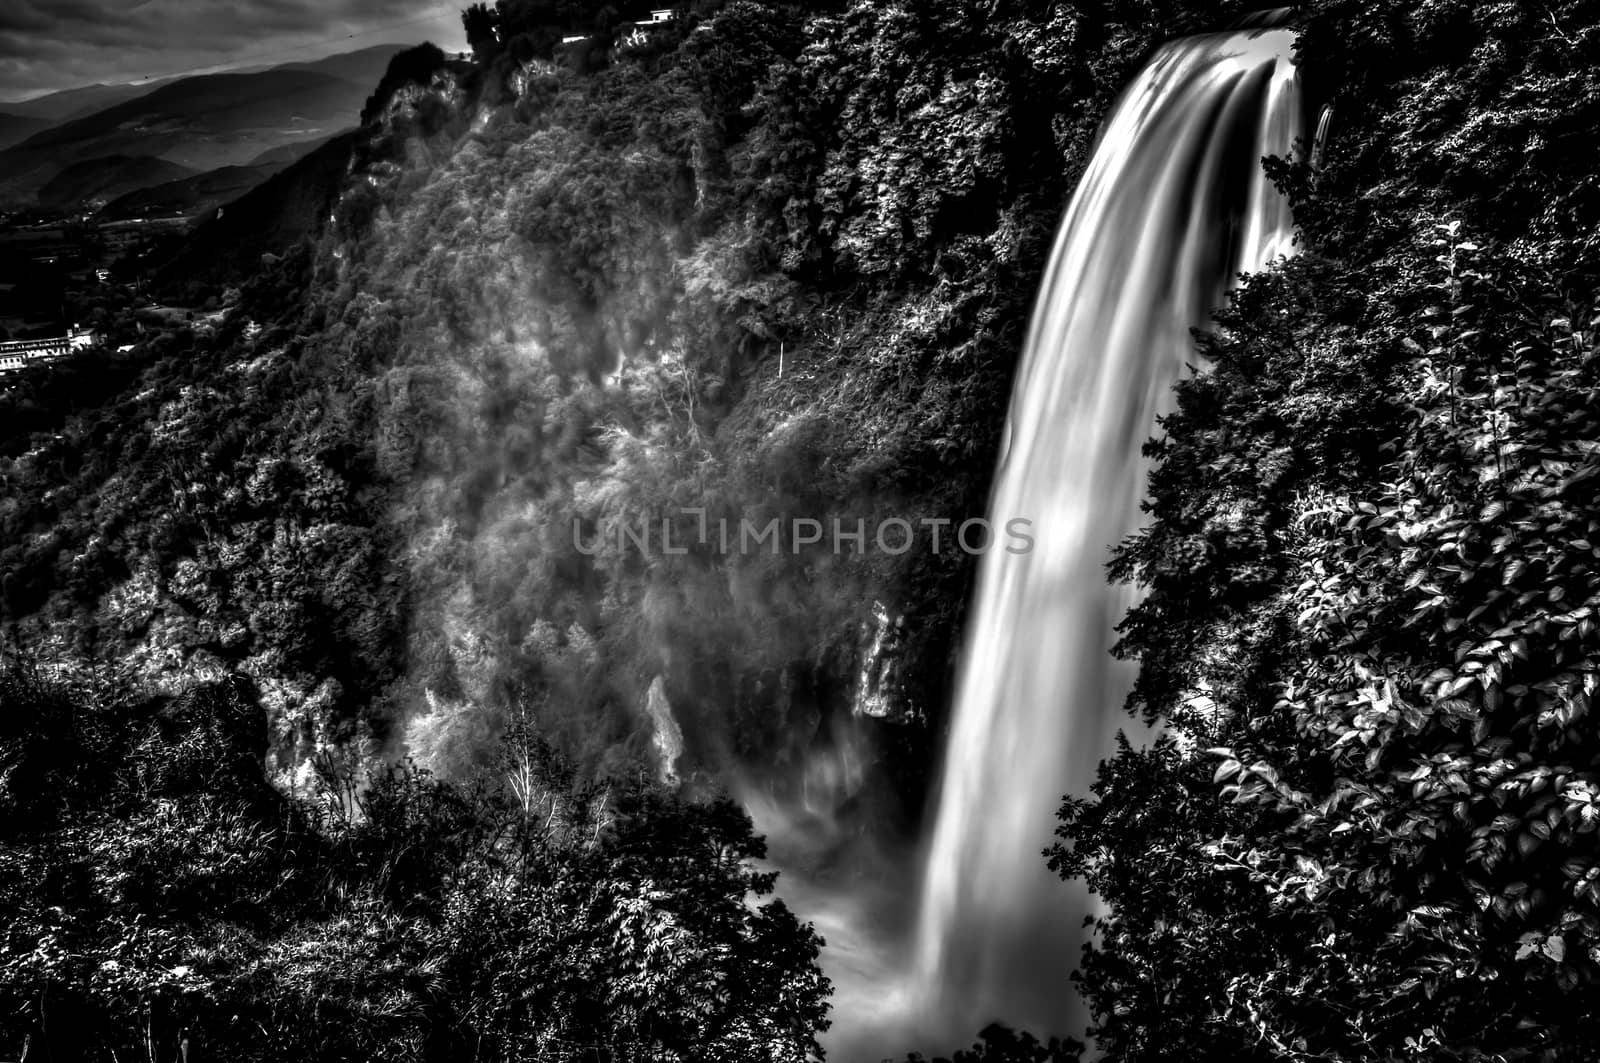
[0,0,1600,1063]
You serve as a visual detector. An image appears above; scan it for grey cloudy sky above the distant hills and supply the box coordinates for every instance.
[0,0,466,107]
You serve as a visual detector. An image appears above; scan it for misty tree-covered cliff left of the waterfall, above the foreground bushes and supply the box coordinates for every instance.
[0,2,1226,810]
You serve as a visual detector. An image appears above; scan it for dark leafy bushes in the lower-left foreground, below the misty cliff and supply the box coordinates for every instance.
[0,666,827,1063]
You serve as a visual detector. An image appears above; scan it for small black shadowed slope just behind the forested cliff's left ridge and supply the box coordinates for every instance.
[155,130,358,288]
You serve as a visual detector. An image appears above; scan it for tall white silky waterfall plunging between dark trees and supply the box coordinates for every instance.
[912,26,1301,1037]
